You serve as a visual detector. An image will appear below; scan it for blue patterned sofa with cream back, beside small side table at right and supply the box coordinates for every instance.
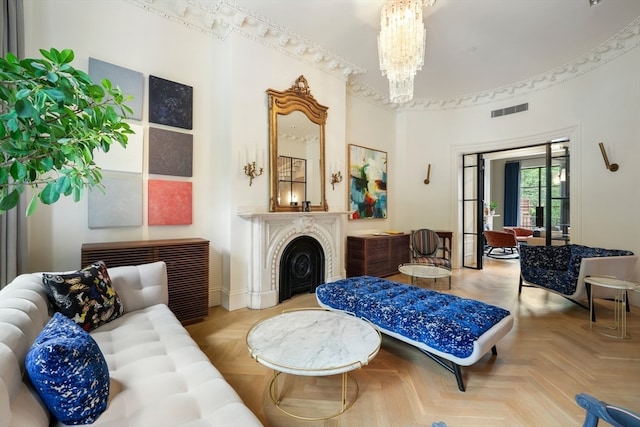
[518,244,638,308]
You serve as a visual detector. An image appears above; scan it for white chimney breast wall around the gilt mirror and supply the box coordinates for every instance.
[225,34,346,309]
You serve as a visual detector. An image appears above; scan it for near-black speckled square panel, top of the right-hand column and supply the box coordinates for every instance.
[149,76,193,129]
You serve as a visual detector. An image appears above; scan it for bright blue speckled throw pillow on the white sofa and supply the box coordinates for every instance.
[25,313,109,425]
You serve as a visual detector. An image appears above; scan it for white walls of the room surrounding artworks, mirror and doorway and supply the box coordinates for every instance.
[25,0,640,309]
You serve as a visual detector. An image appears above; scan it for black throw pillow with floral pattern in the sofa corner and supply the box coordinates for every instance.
[42,261,123,331]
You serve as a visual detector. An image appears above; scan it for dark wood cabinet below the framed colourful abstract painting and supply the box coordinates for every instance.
[347,234,410,277]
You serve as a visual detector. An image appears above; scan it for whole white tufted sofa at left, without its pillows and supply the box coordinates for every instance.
[0,262,261,427]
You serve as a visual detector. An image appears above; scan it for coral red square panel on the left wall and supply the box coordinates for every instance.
[148,179,193,225]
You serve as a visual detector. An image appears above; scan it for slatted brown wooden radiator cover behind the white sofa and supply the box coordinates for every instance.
[82,238,209,324]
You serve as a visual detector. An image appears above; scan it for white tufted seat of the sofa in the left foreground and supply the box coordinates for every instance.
[84,304,256,426]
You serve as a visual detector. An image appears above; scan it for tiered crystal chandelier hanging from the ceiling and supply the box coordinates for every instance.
[378,0,435,104]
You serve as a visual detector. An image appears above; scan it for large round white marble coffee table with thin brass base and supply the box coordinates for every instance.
[247,308,382,421]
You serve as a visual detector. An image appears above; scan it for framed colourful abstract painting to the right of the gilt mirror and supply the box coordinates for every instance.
[349,144,387,219]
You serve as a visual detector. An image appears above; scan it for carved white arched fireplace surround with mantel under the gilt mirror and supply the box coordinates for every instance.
[239,212,347,309]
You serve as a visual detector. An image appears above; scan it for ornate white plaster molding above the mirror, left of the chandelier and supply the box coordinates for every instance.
[125,0,366,81]
